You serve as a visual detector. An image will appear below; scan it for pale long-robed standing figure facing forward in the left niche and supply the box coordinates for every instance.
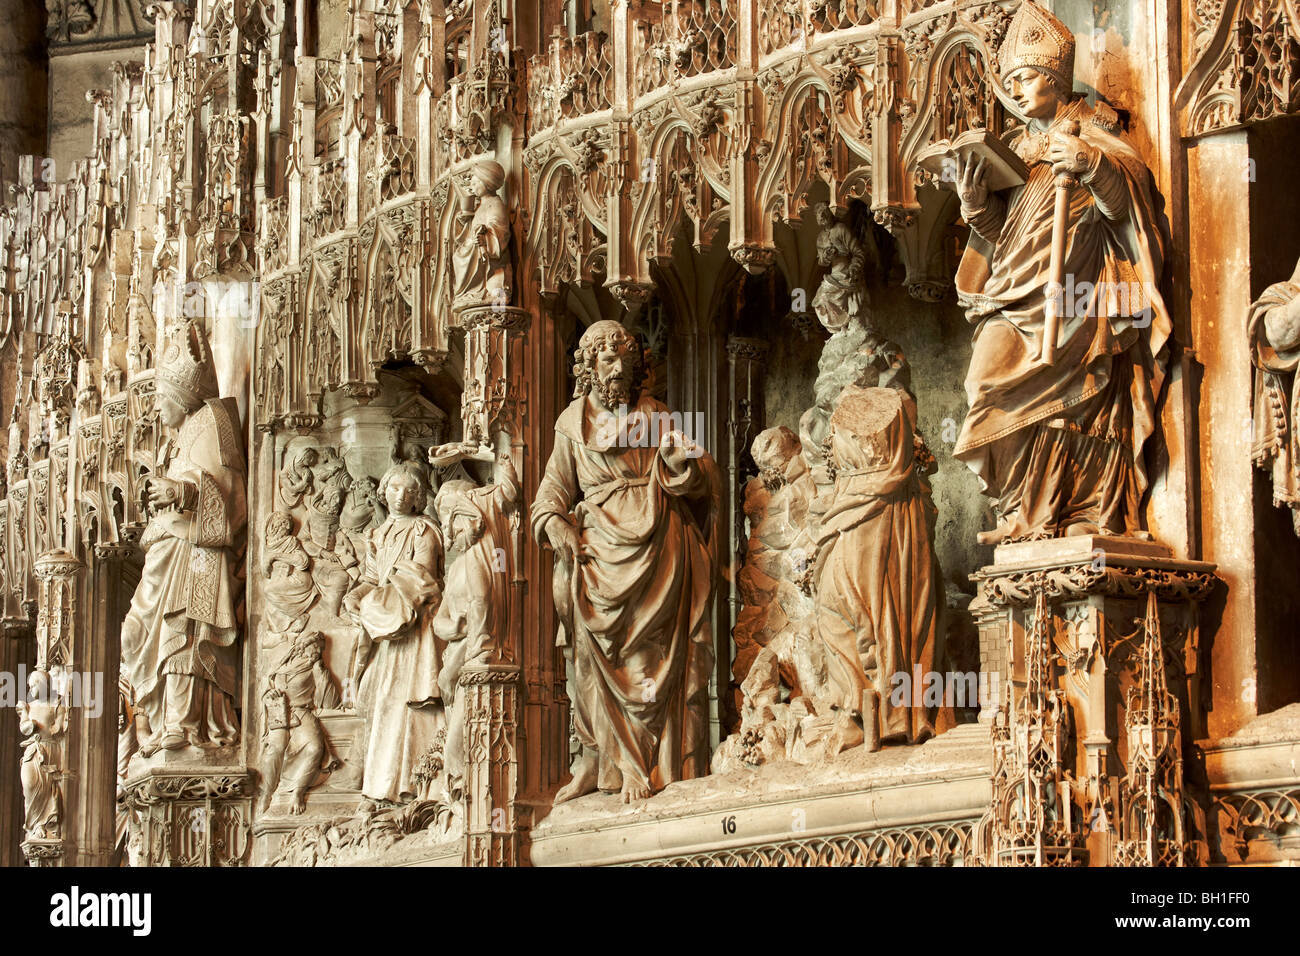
[345,462,443,803]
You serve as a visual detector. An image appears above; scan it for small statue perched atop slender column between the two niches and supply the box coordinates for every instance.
[451,159,511,308]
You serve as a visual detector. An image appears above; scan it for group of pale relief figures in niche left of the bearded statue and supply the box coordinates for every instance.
[253,421,521,845]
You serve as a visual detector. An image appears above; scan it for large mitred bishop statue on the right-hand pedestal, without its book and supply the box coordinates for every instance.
[953,0,1171,544]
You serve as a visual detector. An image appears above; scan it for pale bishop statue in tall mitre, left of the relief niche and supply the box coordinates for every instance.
[122,323,247,757]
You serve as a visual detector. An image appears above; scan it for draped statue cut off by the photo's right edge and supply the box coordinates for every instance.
[1247,263,1300,535]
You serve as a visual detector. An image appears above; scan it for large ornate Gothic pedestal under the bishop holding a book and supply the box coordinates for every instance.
[971,536,1217,866]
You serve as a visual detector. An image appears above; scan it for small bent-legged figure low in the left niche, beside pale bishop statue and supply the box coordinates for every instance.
[261,631,339,814]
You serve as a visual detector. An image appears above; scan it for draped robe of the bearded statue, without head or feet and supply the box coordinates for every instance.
[532,395,718,791]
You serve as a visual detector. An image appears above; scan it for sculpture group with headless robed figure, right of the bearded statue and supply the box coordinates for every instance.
[712,197,953,773]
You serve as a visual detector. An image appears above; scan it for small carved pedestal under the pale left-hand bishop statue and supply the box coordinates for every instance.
[125,770,255,866]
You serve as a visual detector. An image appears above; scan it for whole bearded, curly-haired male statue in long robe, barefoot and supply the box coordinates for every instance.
[532,320,719,804]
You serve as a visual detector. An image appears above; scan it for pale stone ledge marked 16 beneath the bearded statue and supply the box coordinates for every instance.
[529,724,991,866]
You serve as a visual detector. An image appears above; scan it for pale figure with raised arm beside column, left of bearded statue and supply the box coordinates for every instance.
[430,436,521,797]
